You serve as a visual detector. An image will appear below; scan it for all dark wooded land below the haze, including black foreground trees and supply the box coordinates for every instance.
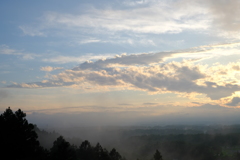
[0,107,240,160]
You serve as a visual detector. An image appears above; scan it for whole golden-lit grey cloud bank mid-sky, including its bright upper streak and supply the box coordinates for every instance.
[5,43,240,100]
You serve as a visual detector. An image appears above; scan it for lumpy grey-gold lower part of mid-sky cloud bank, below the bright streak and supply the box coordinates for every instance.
[8,62,240,100]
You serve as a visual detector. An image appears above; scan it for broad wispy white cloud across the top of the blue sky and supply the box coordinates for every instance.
[19,0,240,43]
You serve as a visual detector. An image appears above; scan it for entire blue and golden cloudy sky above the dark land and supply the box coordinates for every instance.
[0,0,240,125]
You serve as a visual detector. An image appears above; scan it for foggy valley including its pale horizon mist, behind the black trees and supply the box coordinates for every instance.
[24,104,240,160]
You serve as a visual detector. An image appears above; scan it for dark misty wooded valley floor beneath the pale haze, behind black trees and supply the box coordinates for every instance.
[35,122,240,160]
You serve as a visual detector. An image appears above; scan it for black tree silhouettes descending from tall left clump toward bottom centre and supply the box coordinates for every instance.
[0,107,127,160]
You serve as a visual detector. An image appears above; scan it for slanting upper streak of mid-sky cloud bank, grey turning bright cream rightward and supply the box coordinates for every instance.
[73,43,240,70]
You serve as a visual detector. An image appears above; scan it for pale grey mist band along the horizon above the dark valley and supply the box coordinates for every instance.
[28,104,240,128]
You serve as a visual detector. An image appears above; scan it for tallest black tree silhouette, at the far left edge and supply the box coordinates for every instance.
[0,107,40,160]
